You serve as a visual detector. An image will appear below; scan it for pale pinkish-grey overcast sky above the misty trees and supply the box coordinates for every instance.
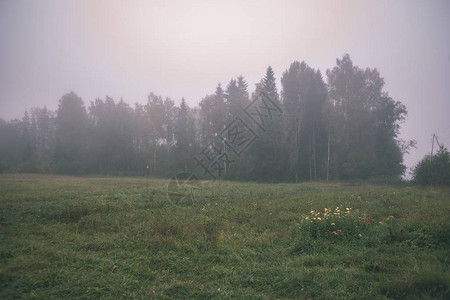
[0,0,450,176]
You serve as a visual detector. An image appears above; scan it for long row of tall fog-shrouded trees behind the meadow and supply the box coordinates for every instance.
[0,54,413,182]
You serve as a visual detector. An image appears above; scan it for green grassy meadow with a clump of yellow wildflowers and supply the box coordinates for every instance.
[0,175,450,299]
